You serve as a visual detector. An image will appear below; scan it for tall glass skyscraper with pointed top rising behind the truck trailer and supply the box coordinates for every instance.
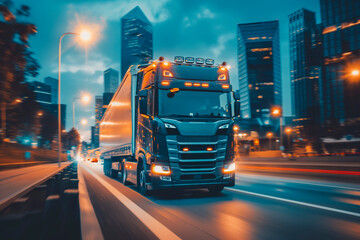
[121,6,153,79]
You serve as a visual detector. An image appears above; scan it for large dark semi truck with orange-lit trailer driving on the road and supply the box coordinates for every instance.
[100,56,240,195]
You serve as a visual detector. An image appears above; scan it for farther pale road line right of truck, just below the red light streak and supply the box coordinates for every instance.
[235,173,360,191]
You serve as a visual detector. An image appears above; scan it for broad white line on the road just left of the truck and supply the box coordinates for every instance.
[86,163,181,240]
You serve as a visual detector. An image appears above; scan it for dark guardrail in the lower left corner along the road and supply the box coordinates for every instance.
[0,163,81,239]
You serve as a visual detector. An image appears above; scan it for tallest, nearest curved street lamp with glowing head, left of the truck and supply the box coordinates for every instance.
[58,30,91,167]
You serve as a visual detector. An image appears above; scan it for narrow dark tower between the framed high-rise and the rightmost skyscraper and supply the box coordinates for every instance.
[289,8,323,127]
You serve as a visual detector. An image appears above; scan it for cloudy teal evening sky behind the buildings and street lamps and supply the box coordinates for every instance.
[14,0,320,141]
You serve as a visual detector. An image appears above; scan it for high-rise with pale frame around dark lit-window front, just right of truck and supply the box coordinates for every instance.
[237,21,282,119]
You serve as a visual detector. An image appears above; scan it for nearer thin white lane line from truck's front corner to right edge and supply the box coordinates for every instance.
[226,187,360,217]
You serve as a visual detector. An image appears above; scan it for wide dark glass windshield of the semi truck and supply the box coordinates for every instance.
[159,89,230,118]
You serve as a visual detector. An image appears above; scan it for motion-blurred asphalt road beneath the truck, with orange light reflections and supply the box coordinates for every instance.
[80,162,360,239]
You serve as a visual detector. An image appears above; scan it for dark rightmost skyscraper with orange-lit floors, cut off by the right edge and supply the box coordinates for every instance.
[320,0,360,123]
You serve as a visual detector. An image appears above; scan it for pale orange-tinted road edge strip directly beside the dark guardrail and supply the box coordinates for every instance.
[78,164,104,240]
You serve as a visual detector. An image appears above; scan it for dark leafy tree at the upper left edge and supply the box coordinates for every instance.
[0,0,40,141]
